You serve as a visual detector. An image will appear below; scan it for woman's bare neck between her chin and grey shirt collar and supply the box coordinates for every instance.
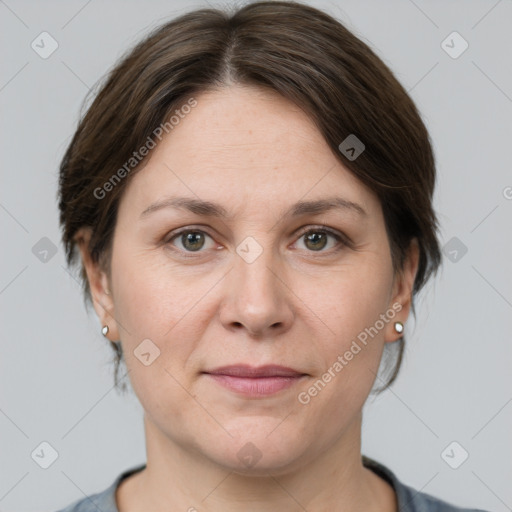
[119,415,396,512]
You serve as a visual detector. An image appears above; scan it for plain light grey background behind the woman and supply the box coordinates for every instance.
[0,0,512,512]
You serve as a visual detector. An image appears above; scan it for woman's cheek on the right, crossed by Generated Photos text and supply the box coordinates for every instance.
[304,263,392,396]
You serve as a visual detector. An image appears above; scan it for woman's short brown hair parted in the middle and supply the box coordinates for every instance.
[59,1,441,391]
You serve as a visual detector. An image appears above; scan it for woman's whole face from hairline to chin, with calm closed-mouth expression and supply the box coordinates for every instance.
[79,86,415,473]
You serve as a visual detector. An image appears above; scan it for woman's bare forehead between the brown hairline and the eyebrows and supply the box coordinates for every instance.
[118,86,377,218]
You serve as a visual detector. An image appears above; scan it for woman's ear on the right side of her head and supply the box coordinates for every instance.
[385,238,420,343]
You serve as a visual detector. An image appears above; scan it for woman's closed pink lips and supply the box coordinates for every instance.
[203,365,307,398]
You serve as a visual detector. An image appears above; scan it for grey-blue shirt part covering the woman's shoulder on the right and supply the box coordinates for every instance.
[363,455,488,512]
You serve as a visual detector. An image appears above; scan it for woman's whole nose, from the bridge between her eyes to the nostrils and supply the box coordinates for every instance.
[221,237,292,334]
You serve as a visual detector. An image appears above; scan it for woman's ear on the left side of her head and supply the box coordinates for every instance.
[75,227,120,341]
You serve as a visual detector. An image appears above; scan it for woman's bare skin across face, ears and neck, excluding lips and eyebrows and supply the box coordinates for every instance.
[78,86,418,512]
